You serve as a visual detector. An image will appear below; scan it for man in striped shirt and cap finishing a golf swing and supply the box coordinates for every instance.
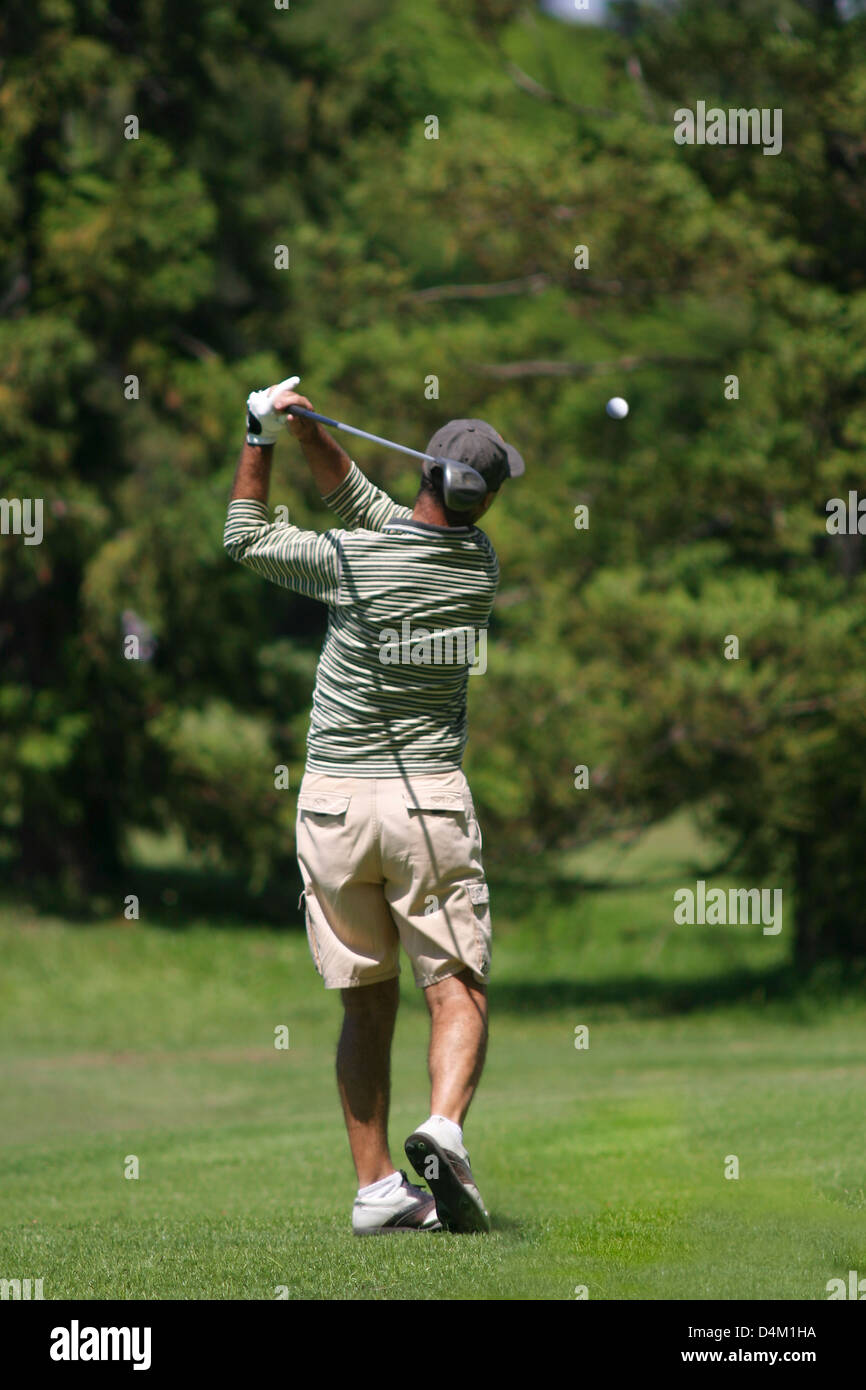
[224,377,524,1234]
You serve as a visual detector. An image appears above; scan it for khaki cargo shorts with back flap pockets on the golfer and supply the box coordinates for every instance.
[297,771,491,990]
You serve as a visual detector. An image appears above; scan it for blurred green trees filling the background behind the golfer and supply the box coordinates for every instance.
[0,0,866,963]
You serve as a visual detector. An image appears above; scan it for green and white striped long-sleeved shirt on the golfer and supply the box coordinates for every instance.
[224,464,499,777]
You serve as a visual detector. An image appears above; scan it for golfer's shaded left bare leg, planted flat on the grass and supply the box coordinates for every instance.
[336,979,400,1187]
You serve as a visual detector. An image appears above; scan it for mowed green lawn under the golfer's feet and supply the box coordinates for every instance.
[0,817,866,1300]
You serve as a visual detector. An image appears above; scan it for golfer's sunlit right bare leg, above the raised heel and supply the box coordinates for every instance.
[424,970,487,1126]
